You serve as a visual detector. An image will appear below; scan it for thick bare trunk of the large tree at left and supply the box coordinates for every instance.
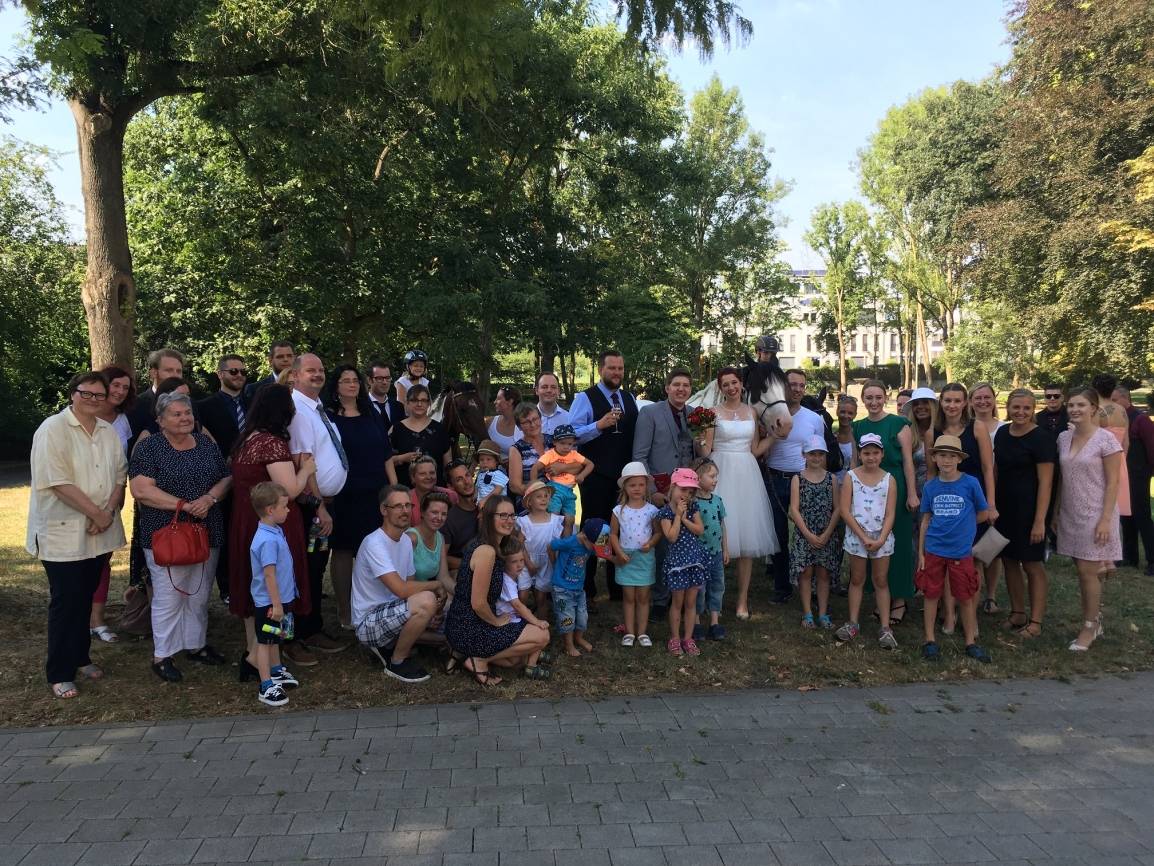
[68,98,136,369]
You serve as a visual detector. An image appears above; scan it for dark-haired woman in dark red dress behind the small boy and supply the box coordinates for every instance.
[228,385,316,682]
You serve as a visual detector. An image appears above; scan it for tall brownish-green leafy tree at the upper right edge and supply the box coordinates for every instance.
[971,0,1154,376]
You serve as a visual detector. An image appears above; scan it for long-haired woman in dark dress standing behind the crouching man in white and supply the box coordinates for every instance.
[325,364,392,629]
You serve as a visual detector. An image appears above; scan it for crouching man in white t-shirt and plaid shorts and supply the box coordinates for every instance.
[352,484,444,682]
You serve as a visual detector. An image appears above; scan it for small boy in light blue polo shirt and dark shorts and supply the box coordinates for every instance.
[248,481,300,707]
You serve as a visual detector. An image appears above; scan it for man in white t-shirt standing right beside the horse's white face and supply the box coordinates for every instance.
[765,369,825,604]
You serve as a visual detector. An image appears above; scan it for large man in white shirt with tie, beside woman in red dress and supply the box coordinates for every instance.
[284,352,349,655]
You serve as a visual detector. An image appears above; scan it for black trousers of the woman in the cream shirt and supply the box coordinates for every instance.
[42,553,112,682]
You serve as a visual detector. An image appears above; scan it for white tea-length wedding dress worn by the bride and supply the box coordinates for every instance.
[710,410,779,559]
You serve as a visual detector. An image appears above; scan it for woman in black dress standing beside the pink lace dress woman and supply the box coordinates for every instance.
[994,388,1058,637]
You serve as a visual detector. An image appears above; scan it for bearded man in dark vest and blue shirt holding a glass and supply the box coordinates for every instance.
[569,349,637,600]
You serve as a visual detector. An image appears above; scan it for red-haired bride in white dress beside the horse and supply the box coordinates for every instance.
[697,367,778,619]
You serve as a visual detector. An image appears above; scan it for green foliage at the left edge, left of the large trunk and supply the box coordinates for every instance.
[0,136,88,458]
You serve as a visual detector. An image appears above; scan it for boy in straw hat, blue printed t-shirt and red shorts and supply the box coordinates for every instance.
[914,435,990,664]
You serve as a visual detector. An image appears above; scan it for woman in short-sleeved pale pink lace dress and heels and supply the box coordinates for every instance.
[1054,388,1122,652]
